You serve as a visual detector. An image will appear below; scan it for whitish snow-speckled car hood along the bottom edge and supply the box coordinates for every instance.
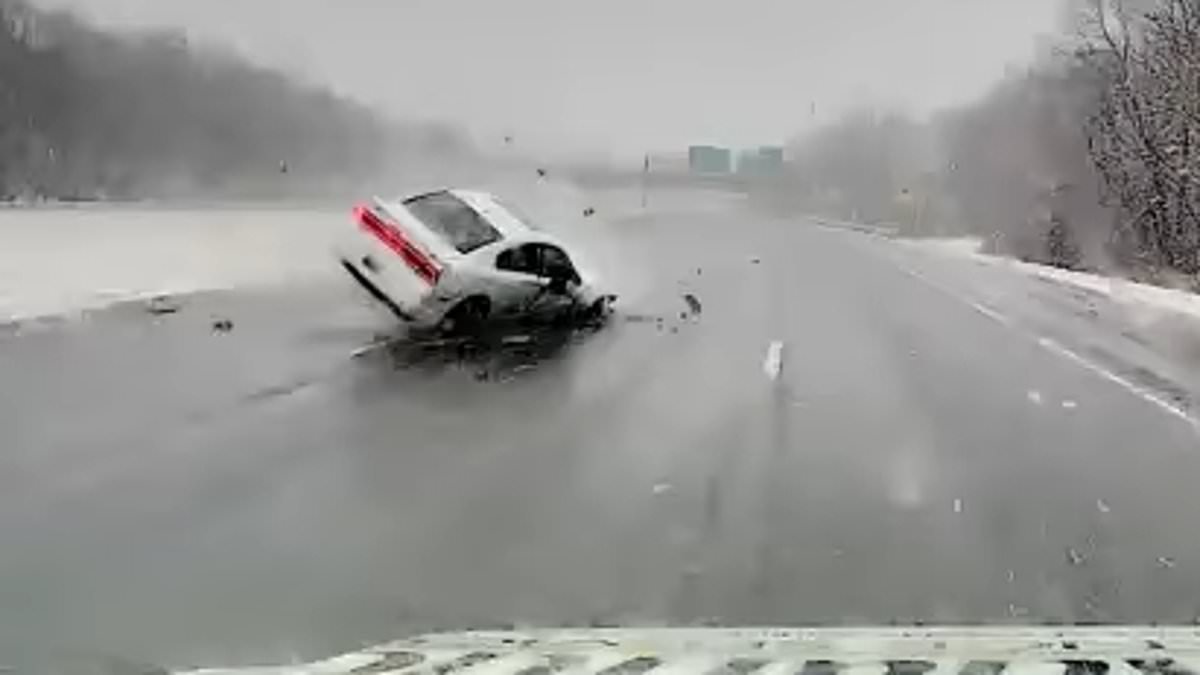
[174,626,1200,675]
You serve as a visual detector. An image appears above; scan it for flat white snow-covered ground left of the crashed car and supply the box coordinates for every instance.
[0,207,346,321]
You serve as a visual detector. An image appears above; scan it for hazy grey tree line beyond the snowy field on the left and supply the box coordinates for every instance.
[0,0,469,199]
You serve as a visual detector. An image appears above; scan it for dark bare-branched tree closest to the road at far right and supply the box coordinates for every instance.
[1079,0,1200,277]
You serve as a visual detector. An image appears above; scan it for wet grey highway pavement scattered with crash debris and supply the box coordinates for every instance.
[0,196,1200,664]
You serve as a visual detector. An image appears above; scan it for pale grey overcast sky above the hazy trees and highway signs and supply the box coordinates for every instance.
[28,0,1058,154]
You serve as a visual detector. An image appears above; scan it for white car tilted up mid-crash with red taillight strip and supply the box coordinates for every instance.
[337,190,616,331]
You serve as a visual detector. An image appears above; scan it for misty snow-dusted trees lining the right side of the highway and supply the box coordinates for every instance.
[788,0,1200,286]
